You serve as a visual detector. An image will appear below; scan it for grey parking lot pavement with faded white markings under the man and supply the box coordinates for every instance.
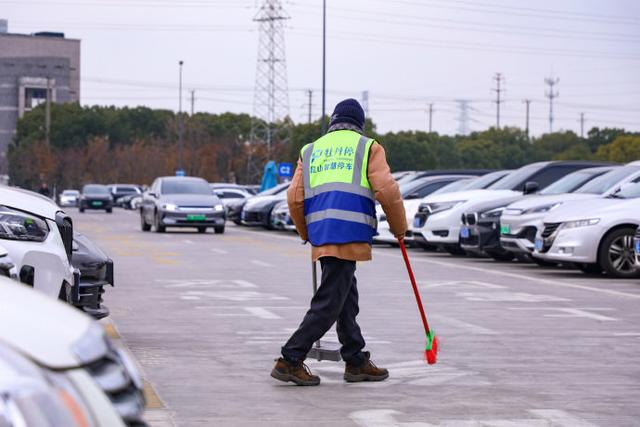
[72,210,640,427]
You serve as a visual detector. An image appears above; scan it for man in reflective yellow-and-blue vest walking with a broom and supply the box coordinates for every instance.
[271,99,407,385]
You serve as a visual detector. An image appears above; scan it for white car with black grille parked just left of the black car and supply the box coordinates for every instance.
[413,161,603,254]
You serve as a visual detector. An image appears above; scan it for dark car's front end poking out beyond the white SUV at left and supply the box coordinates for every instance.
[71,232,114,319]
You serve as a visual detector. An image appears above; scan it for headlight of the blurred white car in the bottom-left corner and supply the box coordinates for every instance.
[0,346,94,427]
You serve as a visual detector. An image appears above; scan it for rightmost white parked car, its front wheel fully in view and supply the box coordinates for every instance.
[534,183,640,278]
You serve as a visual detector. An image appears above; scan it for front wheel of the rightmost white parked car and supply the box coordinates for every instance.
[598,227,640,279]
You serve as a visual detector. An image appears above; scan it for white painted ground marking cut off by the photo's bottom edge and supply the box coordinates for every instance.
[349,409,596,427]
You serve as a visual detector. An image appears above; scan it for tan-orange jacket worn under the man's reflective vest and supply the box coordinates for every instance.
[287,142,407,261]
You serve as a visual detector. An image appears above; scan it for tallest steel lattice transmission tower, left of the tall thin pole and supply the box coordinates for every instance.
[251,0,289,154]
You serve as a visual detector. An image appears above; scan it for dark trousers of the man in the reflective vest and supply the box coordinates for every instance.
[282,257,365,366]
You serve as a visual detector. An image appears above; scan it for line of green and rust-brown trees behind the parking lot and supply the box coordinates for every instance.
[8,103,640,188]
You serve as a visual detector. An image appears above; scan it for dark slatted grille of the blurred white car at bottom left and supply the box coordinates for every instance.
[86,349,145,426]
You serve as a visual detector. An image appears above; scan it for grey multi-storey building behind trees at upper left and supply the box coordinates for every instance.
[0,20,80,175]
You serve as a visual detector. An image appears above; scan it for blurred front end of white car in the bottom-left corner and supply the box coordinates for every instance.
[0,277,144,427]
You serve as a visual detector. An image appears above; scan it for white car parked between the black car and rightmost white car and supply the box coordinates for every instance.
[500,165,640,254]
